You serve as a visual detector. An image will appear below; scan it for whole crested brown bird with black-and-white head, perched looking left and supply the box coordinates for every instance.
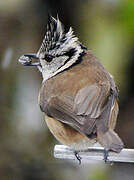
[19,16,124,163]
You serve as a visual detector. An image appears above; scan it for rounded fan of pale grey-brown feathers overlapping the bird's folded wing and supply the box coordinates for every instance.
[74,85,109,118]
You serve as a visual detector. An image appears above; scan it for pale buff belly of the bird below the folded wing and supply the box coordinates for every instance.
[45,114,96,150]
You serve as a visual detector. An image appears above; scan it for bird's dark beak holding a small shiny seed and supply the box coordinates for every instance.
[19,54,40,66]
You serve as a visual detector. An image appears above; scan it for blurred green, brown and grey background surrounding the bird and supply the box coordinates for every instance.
[0,0,134,180]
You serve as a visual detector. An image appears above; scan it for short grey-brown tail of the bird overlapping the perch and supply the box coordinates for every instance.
[97,129,124,153]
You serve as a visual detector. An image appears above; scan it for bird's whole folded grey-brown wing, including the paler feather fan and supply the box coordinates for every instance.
[42,83,113,135]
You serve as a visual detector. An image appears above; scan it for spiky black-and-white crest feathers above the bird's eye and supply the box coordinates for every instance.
[37,17,82,60]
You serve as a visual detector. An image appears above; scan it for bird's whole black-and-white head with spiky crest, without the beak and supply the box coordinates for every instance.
[33,17,85,81]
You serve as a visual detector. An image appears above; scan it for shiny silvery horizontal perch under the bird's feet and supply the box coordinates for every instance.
[54,145,134,163]
